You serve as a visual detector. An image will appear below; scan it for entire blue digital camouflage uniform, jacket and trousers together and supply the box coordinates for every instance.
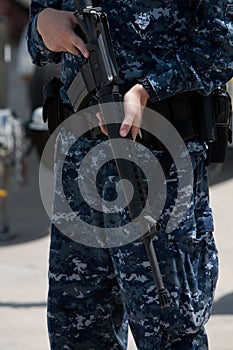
[28,0,233,350]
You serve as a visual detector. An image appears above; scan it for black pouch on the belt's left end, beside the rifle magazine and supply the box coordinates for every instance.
[43,77,64,135]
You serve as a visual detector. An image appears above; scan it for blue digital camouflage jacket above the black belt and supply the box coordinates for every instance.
[28,0,233,103]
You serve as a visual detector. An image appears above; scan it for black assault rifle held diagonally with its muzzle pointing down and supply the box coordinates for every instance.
[68,0,169,308]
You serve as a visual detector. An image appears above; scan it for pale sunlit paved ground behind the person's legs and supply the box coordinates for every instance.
[0,45,233,350]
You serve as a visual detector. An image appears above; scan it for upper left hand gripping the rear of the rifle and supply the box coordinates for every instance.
[37,8,89,58]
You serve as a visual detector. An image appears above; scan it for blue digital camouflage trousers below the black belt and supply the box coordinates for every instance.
[48,135,218,350]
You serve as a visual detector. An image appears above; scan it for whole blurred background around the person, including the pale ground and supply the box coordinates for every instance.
[0,0,233,350]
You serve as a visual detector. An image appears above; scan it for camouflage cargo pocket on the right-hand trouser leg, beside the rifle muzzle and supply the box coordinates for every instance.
[164,233,218,337]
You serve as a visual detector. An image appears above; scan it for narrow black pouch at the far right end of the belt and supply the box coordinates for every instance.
[207,87,232,164]
